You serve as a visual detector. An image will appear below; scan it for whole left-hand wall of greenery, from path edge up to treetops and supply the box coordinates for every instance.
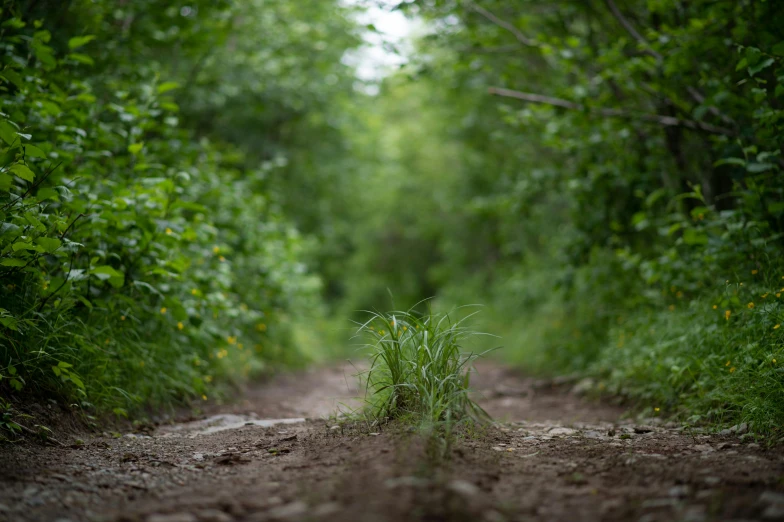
[0,0,355,415]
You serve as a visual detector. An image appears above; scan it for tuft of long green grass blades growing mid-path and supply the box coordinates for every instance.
[357,310,488,424]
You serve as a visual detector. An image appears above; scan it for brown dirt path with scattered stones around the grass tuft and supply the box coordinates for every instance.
[0,363,784,522]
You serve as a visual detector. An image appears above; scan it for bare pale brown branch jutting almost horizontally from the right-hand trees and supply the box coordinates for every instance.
[488,87,735,136]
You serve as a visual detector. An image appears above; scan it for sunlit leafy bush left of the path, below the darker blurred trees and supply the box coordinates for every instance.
[0,3,328,415]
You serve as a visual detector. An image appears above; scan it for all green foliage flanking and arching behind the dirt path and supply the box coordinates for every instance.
[0,0,784,431]
